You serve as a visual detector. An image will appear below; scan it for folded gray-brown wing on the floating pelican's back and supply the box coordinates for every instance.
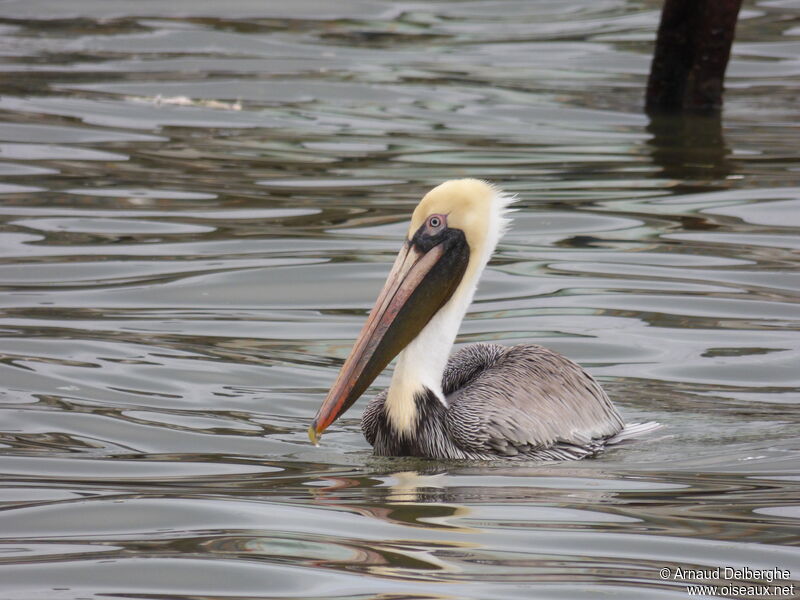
[443,344,623,458]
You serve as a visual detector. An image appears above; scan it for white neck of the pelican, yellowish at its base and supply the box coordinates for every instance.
[384,192,513,435]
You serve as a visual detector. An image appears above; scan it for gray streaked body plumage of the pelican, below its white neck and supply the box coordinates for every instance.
[361,344,649,460]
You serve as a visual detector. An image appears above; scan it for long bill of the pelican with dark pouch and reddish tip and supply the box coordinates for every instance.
[308,232,469,445]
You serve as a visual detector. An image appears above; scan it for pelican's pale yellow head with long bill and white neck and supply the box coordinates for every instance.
[308,179,511,444]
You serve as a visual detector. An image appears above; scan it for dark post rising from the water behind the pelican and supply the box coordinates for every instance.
[645,0,742,112]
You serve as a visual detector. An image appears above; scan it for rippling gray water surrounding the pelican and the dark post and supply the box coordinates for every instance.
[0,0,800,600]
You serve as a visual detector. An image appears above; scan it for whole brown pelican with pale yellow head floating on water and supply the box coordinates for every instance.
[308,179,649,460]
